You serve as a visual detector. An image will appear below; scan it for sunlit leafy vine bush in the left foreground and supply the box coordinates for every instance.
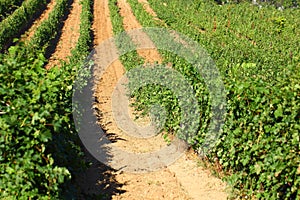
[0,46,71,199]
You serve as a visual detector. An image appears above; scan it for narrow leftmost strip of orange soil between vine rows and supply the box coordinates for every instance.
[21,0,56,41]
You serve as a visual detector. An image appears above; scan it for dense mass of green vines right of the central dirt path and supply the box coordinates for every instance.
[129,0,300,199]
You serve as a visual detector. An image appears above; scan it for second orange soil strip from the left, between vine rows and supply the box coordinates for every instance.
[46,0,81,69]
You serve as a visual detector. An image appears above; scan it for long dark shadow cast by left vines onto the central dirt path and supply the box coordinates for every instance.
[49,77,125,200]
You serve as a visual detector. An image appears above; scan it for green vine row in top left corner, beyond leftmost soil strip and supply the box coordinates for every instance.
[0,0,47,52]
